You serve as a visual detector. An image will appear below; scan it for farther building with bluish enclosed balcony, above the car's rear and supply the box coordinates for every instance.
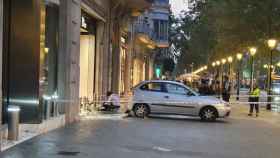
[133,0,171,81]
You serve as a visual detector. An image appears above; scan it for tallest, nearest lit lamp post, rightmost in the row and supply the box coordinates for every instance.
[266,39,277,110]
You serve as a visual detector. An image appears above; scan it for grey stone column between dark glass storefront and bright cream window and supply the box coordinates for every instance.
[58,0,81,123]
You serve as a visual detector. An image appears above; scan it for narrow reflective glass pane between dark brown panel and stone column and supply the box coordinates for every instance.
[39,0,59,105]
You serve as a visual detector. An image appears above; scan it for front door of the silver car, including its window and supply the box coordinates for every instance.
[165,83,195,115]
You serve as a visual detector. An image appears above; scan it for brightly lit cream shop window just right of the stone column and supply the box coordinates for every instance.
[79,11,96,103]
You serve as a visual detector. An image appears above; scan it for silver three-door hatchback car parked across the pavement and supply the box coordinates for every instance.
[129,80,231,121]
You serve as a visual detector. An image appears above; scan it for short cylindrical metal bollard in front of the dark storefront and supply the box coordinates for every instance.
[8,105,20,140]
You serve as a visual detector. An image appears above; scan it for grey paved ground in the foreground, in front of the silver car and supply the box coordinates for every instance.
[0,117,280,158]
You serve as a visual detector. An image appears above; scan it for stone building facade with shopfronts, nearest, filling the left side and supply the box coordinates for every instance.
[0,0,152,123]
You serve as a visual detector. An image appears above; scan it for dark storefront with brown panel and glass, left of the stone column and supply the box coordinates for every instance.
[2,0,59,123]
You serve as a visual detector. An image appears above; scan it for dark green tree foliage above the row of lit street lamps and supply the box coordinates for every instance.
[175,0,280,75]
